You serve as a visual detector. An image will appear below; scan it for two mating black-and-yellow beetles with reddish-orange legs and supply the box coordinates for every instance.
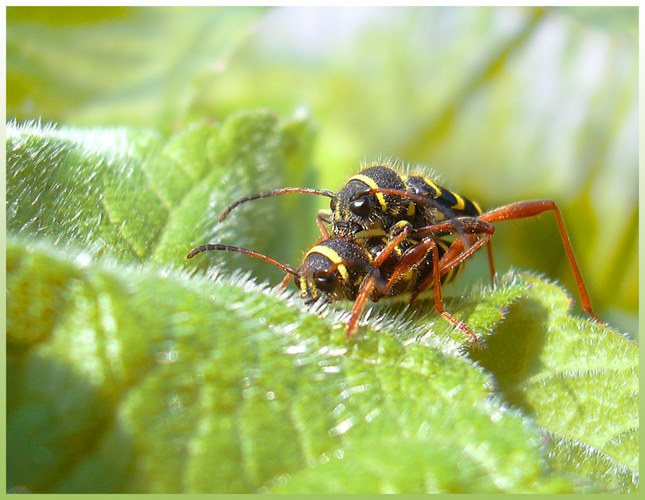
[188,162,600,342]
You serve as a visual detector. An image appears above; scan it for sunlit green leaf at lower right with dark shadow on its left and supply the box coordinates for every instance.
[473,278,639,492]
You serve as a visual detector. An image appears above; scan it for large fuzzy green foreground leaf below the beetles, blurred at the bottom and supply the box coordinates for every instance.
[7,240,571,492]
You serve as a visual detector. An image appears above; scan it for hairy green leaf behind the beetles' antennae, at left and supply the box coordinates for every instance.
[7,112,287,270]
